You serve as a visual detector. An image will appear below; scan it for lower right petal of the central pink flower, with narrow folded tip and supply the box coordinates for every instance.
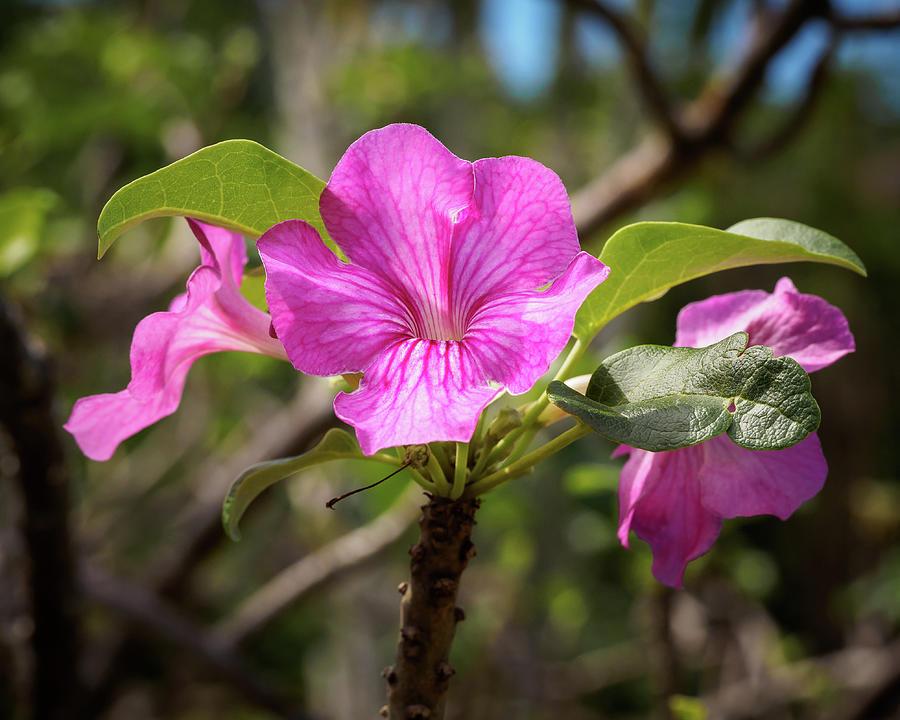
[465,252,609,393]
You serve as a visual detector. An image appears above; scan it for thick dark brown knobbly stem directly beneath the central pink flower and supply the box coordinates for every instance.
[381,497,479,720]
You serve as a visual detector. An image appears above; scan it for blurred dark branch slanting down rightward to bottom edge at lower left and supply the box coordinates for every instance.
[79,564,306,720]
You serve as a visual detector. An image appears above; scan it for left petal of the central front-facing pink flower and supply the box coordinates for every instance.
[258,220,410,375]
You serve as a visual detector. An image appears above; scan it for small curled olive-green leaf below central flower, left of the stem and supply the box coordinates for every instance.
[222,428,366,540]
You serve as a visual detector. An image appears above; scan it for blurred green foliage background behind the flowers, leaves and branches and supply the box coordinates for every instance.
[0,0,900,720]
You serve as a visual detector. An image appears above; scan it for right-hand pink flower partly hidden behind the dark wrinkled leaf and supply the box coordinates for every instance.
[613,278,855,587]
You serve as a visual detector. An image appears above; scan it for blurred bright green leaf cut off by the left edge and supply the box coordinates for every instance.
[0,188,57,277]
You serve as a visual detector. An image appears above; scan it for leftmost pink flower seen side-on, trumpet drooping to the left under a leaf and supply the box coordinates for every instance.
[65,220,285,460]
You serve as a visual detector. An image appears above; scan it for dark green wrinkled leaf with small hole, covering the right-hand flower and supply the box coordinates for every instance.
[548,333,820,452]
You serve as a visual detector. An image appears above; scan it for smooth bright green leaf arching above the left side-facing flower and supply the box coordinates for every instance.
[97,140,334,257]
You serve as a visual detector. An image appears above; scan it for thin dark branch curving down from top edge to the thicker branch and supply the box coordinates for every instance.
[567,0,681,139]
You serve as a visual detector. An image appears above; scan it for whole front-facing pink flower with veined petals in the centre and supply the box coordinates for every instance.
[258,125,608,454]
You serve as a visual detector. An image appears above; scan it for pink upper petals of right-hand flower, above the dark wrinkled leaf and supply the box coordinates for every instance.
[675,278,855,372]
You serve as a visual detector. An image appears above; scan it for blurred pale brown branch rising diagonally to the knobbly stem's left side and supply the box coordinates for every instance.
[215,485,421,647]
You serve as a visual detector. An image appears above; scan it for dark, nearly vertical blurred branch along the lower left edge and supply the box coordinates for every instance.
[0,300,81,720]
